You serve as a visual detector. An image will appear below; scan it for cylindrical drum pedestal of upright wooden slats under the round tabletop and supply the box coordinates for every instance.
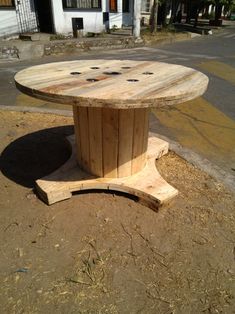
[74,106,149,178]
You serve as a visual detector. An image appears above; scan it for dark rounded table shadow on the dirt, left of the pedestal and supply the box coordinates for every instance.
[0,126,74,188]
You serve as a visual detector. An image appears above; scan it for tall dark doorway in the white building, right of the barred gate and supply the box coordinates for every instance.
[34,0,54,33]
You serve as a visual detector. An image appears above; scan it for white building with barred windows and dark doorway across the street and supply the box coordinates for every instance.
[0,0,141,37]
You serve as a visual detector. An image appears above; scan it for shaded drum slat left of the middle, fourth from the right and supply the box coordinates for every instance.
[88,108,103,177]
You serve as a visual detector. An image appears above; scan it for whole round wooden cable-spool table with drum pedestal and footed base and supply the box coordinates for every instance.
[15,60,208,207]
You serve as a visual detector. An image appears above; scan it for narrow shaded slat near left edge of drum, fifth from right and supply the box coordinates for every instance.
[78,107,90,172]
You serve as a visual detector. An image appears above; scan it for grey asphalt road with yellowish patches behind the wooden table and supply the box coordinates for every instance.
[0,26,235,182]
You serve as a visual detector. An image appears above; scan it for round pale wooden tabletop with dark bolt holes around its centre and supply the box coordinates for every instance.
[15,59,208,109]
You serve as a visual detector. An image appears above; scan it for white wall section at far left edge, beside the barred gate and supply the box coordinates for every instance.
[0,9,19,37]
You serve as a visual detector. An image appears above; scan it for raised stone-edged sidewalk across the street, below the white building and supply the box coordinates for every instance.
[0,32,191,60]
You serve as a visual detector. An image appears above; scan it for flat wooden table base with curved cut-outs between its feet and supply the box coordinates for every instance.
[36,136,178,210]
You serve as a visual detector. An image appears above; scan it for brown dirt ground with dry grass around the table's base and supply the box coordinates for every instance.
[0,111,235,314]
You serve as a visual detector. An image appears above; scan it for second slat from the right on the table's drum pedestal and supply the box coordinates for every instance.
[118,109,134,178]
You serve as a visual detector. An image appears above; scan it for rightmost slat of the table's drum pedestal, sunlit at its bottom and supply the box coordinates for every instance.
[132,108,148,174]
